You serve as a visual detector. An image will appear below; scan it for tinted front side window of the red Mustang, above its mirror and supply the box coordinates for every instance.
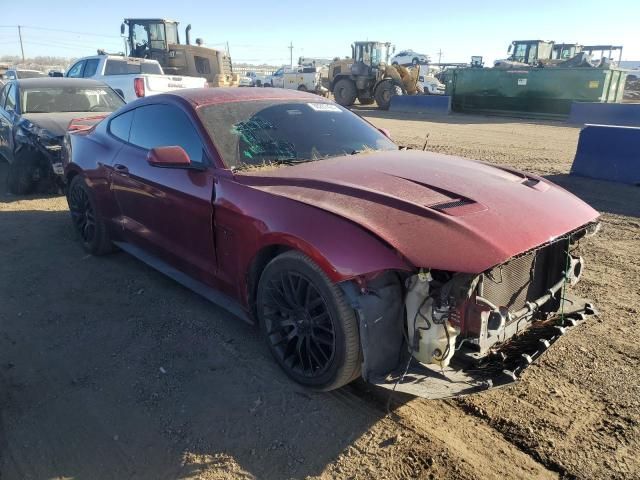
[129,105,204,163]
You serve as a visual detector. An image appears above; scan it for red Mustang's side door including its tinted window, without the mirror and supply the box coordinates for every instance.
[111,104,216,283]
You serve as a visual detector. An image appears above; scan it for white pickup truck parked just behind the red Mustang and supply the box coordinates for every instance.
[65,55,207,102]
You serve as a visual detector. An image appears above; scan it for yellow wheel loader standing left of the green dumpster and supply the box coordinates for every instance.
[328,41,424,110]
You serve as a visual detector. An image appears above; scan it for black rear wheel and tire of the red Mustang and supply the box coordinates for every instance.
[67,175,115,255]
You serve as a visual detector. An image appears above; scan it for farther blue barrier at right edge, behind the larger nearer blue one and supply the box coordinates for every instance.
[567,102,640,127]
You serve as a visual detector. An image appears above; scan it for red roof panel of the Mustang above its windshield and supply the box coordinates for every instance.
[168,87,331,107]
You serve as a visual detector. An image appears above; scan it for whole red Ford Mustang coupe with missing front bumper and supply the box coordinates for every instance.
[65,89,598,398]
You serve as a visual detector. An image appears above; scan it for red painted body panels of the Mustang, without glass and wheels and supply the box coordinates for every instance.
[66,88,598,316]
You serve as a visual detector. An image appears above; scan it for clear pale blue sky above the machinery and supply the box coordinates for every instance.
[0,0,640,65]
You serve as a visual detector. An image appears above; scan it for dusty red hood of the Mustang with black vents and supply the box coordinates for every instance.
[236,151,598,273]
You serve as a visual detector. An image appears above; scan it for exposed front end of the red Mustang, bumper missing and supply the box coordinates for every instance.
[343,223,599,399]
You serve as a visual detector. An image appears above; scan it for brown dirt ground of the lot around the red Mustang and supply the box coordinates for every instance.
[0,109,640,480]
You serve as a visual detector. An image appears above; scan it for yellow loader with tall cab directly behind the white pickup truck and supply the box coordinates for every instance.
[120,18,238,87]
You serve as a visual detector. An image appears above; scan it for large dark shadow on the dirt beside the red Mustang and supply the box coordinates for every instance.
[0,207,410,480]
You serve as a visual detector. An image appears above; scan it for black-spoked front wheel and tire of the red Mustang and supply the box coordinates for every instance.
[257,251,360,391]
